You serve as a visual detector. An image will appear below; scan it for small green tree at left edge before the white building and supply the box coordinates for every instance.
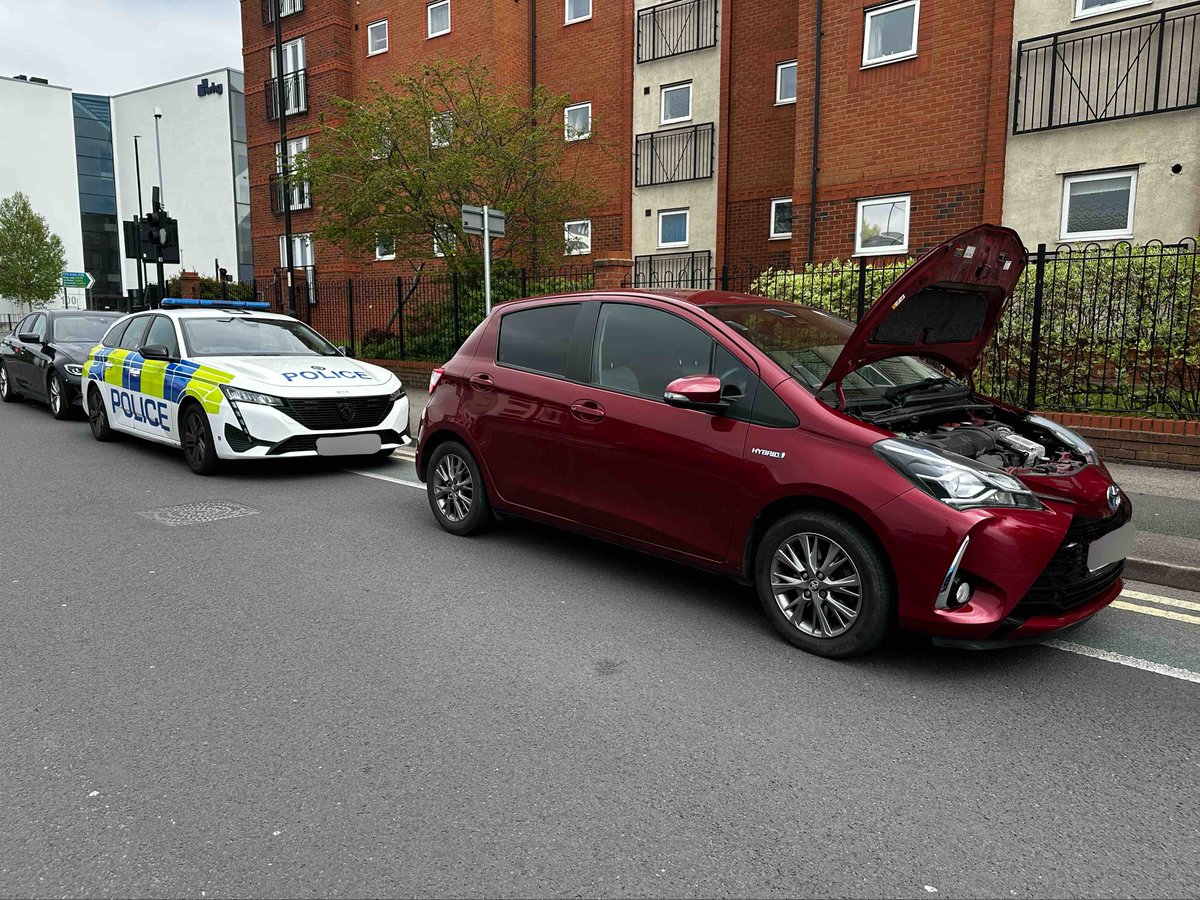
[0,191,67,310]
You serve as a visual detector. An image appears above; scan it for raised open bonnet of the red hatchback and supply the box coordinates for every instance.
[821,224,1026,388]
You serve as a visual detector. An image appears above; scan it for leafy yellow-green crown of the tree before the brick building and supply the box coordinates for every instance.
[293,59,599,271]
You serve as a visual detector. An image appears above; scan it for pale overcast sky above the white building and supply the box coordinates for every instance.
[0,0,243,94]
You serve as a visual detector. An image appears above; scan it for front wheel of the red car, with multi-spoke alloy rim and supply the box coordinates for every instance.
[755,511,895,659]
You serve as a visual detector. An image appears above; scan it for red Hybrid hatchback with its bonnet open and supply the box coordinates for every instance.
[416,226,1133,656]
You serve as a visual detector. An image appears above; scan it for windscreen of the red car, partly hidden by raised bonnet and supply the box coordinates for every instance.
[704,304,944,396]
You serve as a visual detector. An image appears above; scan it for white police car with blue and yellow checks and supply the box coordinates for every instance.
[83,299,410,475]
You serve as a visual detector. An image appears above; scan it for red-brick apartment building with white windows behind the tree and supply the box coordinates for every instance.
[242,0,1014,285]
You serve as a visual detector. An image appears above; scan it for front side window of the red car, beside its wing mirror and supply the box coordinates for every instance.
[592,304,714,400]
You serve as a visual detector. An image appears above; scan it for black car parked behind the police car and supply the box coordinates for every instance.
[0,310,125,419]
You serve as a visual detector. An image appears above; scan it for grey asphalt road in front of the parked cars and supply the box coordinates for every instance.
[0,404,1200,898]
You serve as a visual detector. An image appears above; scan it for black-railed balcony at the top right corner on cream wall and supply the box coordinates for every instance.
[1013,2,1200,134]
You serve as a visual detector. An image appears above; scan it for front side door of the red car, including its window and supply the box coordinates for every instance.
[572,302,757,560]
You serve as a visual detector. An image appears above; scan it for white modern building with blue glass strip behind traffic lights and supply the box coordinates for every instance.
[0,68,253,318]
